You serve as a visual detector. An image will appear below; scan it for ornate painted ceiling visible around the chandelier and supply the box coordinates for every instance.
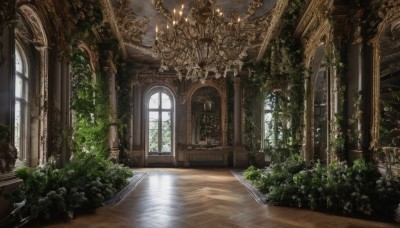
[107,0,277,66]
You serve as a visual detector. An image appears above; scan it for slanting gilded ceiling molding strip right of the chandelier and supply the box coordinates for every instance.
[256,0,288,62]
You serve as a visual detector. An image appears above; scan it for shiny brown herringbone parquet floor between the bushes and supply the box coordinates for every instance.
[34,168,398,228]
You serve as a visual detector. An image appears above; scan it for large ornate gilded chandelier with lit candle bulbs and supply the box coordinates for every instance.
[155,0,262,82]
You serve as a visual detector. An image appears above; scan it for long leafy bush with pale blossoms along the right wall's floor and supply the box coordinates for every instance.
[244,156,400,215]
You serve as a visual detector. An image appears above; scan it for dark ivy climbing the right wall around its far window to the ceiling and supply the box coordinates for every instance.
[244,0,308,162]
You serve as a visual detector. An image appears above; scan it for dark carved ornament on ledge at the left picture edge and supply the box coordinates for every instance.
[0,125,18,173]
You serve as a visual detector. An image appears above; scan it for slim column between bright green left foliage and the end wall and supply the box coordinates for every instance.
[103,52,119,163]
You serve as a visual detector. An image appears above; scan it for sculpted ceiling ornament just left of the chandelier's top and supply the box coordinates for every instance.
[114,0,149,43]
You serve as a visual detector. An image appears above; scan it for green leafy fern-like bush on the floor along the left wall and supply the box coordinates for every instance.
[14,153,132,222]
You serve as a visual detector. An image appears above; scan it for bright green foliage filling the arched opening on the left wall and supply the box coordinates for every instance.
[71,48,109,157]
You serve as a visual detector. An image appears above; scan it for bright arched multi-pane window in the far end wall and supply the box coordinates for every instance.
[148,88,173,155]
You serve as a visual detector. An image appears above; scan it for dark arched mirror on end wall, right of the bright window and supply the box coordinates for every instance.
[191,86,221,146]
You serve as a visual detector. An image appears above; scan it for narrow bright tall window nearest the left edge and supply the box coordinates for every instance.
[14,46,29,161]
